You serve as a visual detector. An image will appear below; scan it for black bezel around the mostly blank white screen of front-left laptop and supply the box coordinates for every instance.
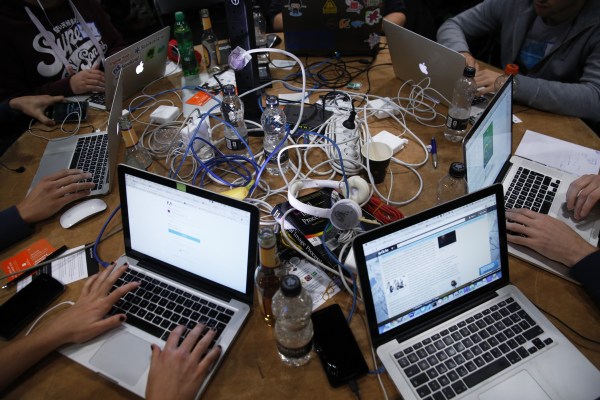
[117,164,260,305]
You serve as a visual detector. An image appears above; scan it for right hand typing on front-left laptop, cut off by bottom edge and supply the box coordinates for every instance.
[146,324,221,400]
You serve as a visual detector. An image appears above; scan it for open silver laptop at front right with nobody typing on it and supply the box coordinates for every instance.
[353,184,600,400]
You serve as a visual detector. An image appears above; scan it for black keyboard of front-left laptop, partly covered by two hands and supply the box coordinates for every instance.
[109,269,234,347]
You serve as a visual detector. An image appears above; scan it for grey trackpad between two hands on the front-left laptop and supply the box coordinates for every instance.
[90,332,152,386]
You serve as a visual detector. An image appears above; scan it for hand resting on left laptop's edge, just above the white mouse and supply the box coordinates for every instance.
[17,169,94,224]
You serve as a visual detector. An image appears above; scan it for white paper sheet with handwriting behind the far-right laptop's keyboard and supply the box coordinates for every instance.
[515,130,600,176]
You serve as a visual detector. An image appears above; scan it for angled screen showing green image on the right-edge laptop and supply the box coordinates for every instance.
[463,79,512,192]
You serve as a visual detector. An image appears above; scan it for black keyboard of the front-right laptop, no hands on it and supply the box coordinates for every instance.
[394,297,553,400]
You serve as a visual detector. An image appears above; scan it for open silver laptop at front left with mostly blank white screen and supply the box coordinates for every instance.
[61,164,259,397]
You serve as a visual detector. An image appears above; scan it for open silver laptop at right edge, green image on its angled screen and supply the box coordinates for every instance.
[463,79,600,282]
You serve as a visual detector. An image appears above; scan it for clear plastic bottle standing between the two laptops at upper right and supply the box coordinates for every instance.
[444,67,477,142]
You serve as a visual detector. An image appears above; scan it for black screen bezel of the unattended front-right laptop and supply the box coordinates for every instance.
[353,184,510,348]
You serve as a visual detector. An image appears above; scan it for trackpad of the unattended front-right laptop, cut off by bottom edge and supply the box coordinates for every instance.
[479,370,550,400]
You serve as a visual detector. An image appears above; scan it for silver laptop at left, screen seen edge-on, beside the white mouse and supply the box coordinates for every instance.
[29,69,123,196]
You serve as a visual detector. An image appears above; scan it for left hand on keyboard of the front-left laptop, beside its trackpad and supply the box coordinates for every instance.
[44,264,139,344]
